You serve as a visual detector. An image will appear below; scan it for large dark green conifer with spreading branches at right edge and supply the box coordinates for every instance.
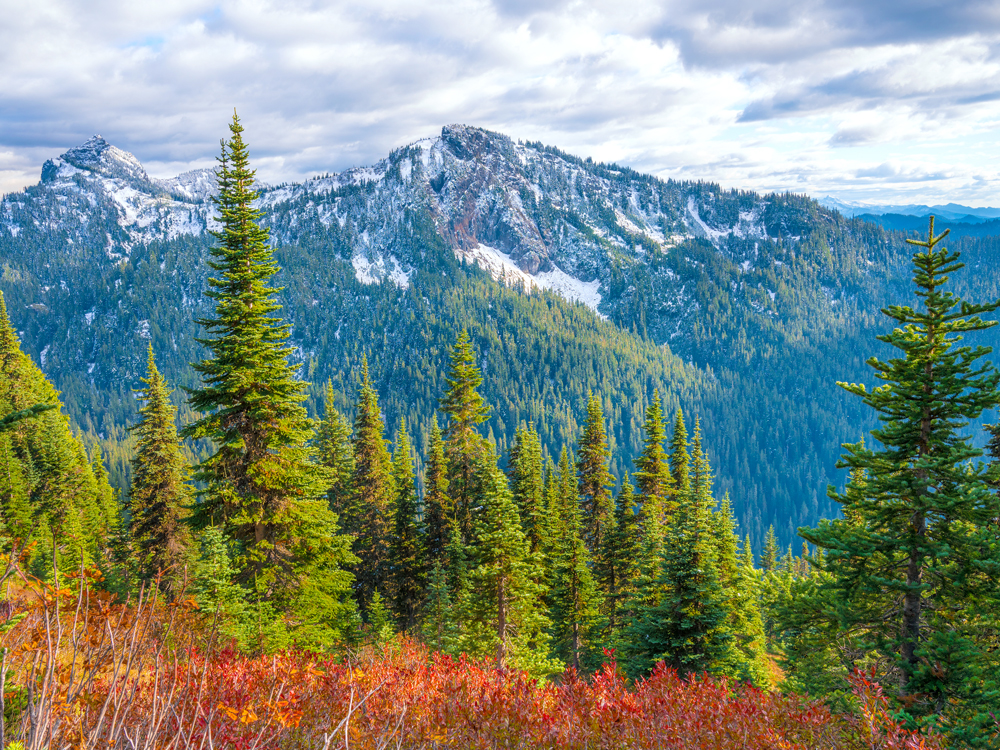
[799,217,1000,728]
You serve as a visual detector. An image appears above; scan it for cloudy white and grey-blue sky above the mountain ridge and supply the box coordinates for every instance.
[0,0,1000,206]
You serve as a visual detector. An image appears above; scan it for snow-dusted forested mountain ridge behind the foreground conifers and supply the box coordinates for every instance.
[0,125,1000,546]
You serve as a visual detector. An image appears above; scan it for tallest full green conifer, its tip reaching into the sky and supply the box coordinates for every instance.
[182,114,329,600]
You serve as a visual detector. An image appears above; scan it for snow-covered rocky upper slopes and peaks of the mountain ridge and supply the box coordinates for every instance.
[0,125,820,324]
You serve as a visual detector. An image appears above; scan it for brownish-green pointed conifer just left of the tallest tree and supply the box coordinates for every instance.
[128,345,192,583]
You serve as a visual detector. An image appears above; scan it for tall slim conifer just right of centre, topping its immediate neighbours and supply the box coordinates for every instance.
[576,391,615,555]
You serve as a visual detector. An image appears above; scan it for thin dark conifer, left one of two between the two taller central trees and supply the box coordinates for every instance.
[392,420,426,632]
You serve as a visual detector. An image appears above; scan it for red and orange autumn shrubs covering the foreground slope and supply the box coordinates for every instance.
[0,572,937,750]
